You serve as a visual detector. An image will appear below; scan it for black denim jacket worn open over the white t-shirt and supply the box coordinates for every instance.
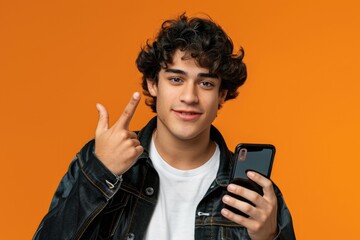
[33,118,295,240]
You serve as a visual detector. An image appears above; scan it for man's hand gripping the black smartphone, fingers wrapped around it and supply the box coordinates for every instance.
[221,171,278,240]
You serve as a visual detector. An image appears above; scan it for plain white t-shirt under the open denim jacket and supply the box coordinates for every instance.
[145,137,220,240]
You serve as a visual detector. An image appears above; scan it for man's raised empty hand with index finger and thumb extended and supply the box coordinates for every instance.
[95,92,144,175]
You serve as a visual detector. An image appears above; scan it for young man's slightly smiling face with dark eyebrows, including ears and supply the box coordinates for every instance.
[147,50,227,140]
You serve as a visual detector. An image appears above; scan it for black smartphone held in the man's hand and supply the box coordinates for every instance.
[226,143,275,217]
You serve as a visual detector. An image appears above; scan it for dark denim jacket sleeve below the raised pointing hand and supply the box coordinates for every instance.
[33,140,121,240]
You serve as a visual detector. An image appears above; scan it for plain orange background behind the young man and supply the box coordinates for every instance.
[0,0,360,239]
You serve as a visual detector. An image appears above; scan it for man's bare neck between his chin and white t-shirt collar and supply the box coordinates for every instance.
[153,128,215,170]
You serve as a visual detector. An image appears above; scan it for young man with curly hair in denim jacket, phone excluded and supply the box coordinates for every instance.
[34,15,295,240]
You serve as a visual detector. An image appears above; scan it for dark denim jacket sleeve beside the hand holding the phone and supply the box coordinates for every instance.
[274,184,296,240]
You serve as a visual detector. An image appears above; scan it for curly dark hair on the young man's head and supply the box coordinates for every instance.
[136,13,247,112]
